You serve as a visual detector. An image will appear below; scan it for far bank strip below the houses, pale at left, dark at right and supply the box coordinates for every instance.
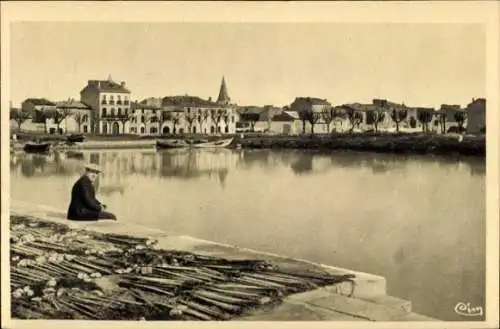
[12,133,486,158]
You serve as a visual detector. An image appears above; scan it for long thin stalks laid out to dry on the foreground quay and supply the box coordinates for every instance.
[10,216,352,321]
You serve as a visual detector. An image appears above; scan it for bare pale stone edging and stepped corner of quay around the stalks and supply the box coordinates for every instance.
[7,200,437,321]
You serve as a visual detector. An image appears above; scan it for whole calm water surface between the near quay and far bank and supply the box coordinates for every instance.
[11,150,485,320]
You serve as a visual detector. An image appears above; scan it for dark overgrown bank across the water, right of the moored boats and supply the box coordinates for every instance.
[238,133,486,156]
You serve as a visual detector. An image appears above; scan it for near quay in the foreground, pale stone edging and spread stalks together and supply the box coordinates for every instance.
[11,202,434,321]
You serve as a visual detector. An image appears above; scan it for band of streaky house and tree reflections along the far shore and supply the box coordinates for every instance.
[10,150,486,181]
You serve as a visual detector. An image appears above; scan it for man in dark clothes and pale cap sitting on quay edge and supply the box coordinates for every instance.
[68,163,116,221]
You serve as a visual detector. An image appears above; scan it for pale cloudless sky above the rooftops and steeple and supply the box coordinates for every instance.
[10,22,486,107]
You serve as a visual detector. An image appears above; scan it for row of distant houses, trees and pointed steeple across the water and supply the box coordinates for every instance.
[11,76,486,135]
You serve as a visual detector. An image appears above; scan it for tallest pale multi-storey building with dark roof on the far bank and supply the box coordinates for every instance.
[80,77,131,135]
